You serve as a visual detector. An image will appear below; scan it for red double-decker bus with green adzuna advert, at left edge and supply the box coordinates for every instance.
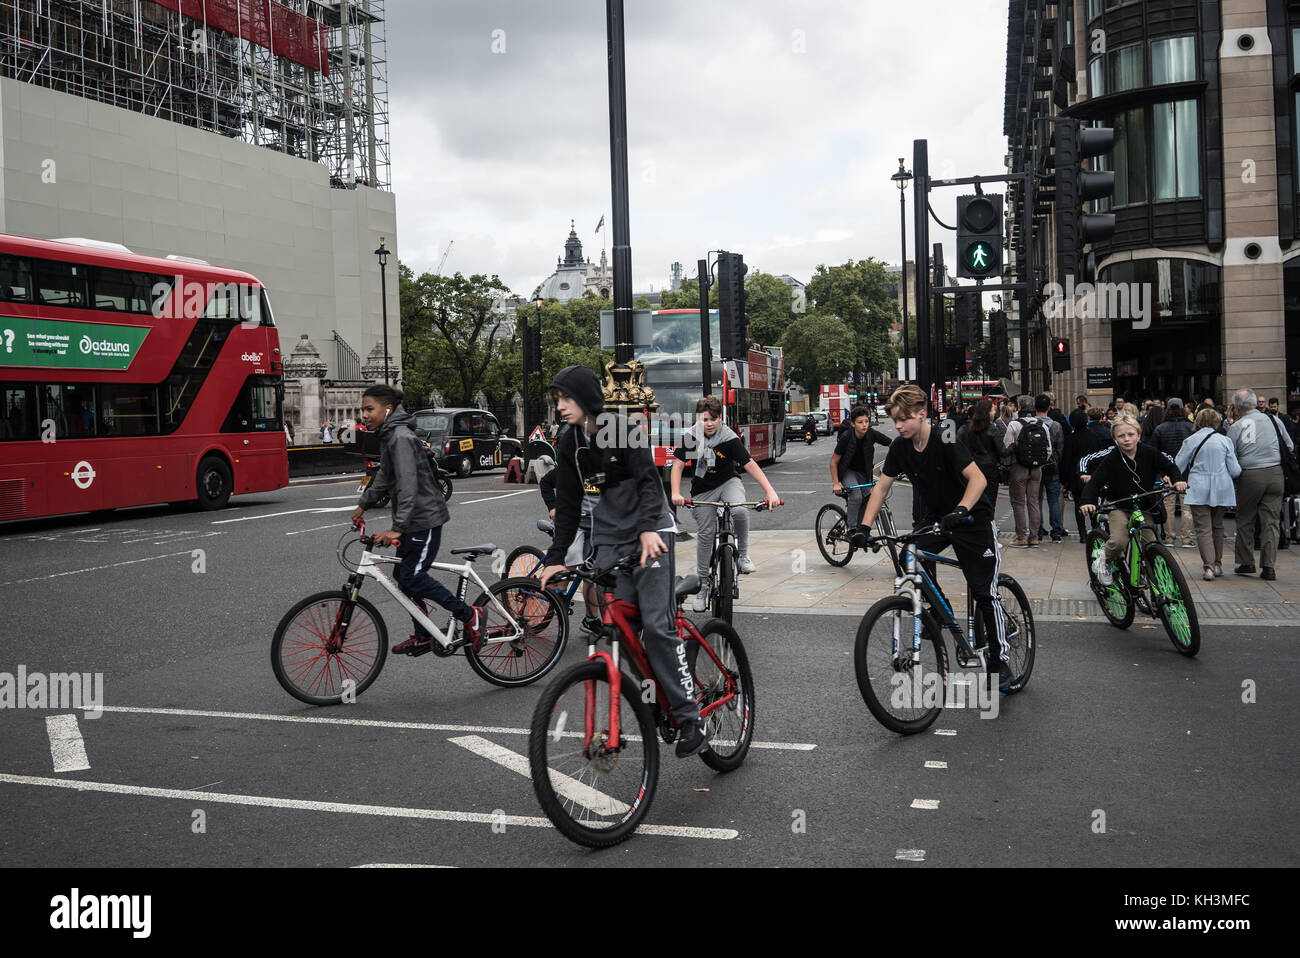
[0,234,289,520]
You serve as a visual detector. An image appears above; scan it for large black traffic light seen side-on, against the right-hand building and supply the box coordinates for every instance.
[1053,120,1115,283]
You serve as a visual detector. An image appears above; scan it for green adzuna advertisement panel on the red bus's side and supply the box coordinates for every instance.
[0,316,150,369]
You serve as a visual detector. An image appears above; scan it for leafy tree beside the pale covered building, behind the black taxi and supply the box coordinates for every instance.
[398,264,511,406]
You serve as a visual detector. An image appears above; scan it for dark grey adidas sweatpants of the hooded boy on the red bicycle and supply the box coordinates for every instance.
[592,532,699,725]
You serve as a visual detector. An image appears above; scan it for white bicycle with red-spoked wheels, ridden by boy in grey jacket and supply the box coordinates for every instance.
[270,523,568,706]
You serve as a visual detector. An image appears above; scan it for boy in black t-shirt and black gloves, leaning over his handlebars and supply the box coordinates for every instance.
[858,385,1011,689]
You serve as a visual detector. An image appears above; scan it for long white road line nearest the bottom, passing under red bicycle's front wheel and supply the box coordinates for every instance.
[0,772,740,840]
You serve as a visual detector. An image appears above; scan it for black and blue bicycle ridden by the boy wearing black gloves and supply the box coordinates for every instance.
[853,523,1037,734]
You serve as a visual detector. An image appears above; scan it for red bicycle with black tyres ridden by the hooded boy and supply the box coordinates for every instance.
[528,554,754,848]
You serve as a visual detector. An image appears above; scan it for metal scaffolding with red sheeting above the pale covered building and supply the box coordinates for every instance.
[0,0,390,190]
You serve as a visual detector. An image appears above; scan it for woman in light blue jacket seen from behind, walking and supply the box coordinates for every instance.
[1174,407,1242,582]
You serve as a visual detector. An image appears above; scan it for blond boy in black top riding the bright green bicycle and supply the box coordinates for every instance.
[1079,413,1187,585]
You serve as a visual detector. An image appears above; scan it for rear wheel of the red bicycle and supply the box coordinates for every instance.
[694,619,754,772]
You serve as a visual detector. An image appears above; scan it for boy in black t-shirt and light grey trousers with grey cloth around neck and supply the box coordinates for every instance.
[668,396,780,612]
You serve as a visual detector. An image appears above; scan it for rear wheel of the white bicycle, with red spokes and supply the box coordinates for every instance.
[465,578,568,689]
